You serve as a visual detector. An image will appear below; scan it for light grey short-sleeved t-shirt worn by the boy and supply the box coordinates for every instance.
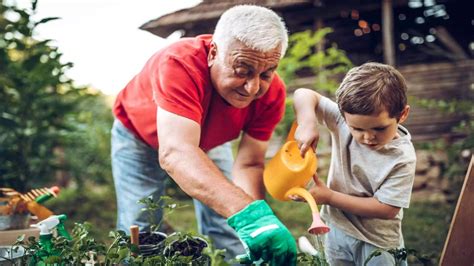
[316,97,416,249]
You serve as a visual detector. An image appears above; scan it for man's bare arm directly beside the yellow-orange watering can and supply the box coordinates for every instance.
[232,134,268,199]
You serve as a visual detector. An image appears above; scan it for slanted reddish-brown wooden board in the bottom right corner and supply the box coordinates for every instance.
[440,156,474,266]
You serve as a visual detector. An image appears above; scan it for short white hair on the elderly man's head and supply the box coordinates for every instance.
[213,5,288,57]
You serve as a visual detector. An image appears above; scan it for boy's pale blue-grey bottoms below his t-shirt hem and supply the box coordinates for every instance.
[324,224,407,266]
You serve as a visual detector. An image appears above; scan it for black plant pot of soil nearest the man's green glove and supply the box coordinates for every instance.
[163,233,211,265]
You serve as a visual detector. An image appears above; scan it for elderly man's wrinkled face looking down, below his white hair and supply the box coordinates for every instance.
[208,41,281,108]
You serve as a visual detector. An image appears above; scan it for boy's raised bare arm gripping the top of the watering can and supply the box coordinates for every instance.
[293,88,321,156]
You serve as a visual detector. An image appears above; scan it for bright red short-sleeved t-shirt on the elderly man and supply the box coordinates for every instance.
[113,35,285,151]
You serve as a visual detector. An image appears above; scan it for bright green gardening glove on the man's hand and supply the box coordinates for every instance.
[227,200,296,265]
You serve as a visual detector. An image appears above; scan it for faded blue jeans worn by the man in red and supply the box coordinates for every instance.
[112,119,245,259]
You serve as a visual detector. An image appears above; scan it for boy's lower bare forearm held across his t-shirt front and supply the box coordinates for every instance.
[310,177,400,219]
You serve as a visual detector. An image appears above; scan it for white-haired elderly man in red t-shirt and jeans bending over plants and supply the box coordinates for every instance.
[112,5,296,265]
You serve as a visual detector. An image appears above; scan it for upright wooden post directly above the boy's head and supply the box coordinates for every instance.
[382,0,395,66]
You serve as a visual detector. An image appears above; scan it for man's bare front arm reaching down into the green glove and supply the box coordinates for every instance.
[157,107,254,218]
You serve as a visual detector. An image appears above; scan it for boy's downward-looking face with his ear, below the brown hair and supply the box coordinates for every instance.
[344,105,410,150]
